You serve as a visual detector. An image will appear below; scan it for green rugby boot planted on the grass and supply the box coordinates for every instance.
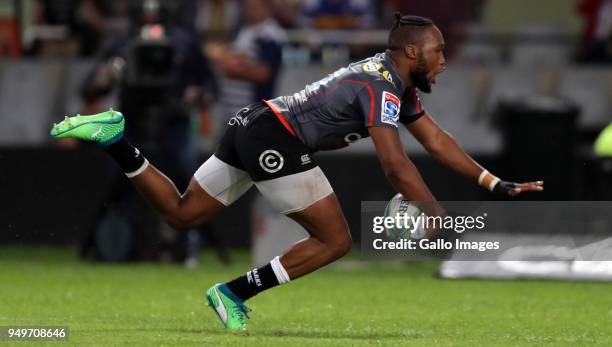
[206,283,251,334]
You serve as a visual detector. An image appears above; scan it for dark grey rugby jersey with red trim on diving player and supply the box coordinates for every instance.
[266,53,424,151]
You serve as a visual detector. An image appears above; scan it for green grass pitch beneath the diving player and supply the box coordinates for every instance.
[0,248,612,346]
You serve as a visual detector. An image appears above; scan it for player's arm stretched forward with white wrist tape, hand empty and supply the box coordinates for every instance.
[406,114,544,196]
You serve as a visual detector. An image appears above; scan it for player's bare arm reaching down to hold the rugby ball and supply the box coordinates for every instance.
[368,127,446,215]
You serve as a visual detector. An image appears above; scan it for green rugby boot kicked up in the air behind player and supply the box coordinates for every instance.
[51,108,125,147]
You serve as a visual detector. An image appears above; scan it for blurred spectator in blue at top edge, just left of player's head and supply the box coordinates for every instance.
[298,0,375,30]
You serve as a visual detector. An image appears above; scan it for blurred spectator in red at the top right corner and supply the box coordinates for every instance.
[576,0,612,63]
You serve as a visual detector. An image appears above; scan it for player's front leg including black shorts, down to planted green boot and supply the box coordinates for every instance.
[206,105,351,331]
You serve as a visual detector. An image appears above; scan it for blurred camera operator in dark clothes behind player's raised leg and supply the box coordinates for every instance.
[81,0,228,265]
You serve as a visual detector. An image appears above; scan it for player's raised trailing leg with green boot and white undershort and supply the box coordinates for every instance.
[51,110,250,229]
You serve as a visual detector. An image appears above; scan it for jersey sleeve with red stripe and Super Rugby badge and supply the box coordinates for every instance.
[357,81,402,128]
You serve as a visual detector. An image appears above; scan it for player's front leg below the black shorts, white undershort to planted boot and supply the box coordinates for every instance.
[206,166,352,331]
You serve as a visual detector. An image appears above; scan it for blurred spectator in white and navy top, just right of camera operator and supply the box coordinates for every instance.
[206,0,286,123]
